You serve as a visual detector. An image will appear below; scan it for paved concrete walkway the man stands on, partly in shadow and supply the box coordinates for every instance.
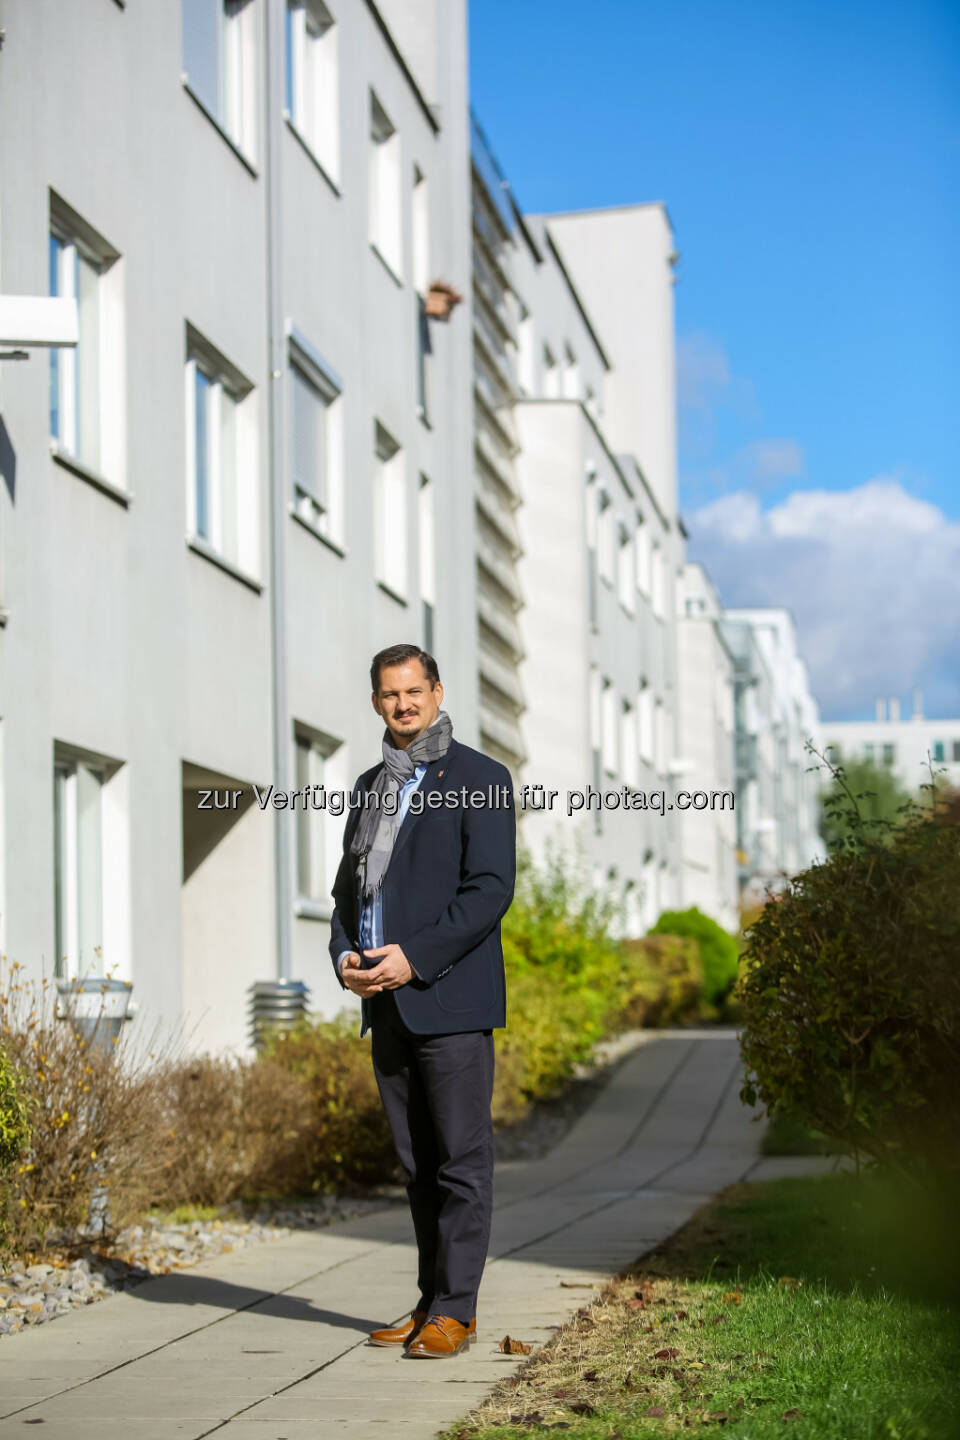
[0,1031,829,1440]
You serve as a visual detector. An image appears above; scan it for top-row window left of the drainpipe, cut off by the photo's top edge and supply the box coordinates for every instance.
[181,0,256,158]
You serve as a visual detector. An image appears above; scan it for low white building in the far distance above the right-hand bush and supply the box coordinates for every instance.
[823,691,960,795]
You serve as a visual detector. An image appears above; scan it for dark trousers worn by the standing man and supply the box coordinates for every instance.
[371,991,494,1325]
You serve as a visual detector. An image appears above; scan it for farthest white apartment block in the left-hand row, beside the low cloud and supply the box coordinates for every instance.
[720,608,823,899]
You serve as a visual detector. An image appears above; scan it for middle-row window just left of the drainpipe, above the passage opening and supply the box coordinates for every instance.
[186,325,261,576]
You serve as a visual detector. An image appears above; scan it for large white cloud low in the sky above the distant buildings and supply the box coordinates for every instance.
[688,477,960,719]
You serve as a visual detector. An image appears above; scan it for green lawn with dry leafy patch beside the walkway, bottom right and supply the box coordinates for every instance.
[450,1175,960,1440]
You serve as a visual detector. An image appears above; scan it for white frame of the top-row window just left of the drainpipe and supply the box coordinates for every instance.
[181,0,258,163]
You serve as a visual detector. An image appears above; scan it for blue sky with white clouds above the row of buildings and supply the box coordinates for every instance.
[471,0,960,719]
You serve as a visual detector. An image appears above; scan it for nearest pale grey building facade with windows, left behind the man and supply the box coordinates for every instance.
[0,0,478,1050]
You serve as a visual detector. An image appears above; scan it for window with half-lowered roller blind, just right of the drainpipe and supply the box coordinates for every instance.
[289,337,344,544]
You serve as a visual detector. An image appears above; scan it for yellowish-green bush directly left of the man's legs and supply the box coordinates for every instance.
[258,1011,397,1192]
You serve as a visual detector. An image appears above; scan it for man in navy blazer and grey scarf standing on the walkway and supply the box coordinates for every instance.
[330,645,517,1359]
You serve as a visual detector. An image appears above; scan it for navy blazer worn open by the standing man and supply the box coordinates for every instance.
[330,740,517,1035]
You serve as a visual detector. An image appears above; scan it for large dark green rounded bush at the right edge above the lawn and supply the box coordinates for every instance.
[740,815,960,1166]
